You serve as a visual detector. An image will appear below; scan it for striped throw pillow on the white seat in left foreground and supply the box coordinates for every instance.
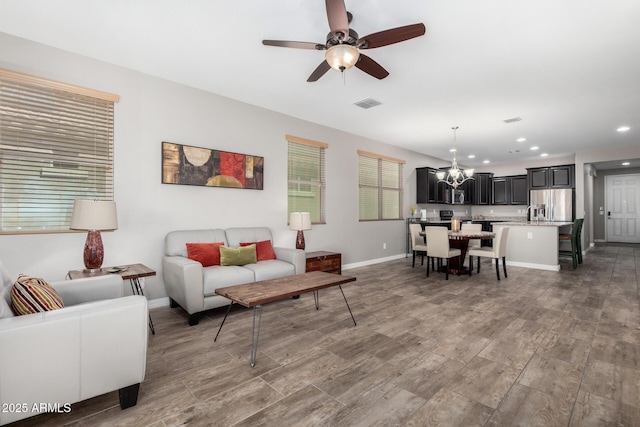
[11,274,64,315]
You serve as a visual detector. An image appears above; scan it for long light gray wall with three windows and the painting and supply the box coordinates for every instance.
[0,33,448,299]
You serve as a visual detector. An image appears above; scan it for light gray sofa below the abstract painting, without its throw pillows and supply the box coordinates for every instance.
[162,227,306,326]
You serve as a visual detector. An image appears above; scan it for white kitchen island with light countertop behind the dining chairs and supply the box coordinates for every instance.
[492,221,573,271]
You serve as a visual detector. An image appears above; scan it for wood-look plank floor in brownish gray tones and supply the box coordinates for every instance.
[15,247,640,427]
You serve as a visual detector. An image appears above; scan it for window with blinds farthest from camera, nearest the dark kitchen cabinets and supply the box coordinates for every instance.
[358,151,404,221]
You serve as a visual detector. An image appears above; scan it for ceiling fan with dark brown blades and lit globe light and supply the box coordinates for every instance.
[262,0,426,82]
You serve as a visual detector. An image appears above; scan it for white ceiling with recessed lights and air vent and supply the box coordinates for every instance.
[0,0,640,167]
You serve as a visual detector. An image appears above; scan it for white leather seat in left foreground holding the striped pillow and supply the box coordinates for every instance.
[0,262,148,425]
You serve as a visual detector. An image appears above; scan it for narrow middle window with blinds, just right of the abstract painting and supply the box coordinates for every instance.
[287,135,328,224]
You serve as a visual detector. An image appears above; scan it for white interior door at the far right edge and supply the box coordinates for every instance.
[604,174,640,243]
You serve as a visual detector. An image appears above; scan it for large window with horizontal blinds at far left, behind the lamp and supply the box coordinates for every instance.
[0,69,118,234]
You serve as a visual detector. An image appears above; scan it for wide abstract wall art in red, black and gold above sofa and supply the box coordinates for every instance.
[162,142,264,190]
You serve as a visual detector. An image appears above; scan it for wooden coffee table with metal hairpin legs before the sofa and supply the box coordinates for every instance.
[213,271,356,368]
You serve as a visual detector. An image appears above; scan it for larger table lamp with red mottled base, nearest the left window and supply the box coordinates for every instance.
[69,200,118,273]
